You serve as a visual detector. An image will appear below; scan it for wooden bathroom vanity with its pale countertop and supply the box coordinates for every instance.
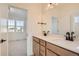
[33,35,79,56]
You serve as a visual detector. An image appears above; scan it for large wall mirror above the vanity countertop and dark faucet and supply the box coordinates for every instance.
[42,3,79,35]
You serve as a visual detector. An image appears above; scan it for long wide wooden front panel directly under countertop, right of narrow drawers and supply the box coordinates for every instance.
[46,42,77,56]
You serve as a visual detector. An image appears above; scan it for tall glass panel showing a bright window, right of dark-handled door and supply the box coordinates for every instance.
[8,7,27,56]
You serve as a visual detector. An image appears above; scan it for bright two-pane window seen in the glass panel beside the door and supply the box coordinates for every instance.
[8,20,24,32]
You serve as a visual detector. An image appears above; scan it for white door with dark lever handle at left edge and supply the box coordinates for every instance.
[0,4,8,56]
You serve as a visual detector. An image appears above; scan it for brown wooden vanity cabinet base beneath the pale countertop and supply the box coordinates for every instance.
[33,37,79,56]
